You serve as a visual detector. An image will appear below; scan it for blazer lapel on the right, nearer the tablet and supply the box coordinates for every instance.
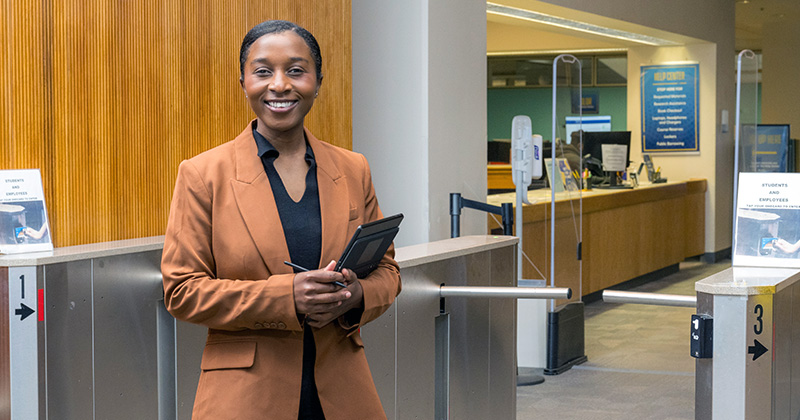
[306,129,350,267]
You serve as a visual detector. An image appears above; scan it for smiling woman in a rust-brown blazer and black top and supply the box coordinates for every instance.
[161,21,400,420]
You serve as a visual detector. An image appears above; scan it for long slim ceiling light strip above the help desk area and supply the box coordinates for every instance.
[486,2,679,46]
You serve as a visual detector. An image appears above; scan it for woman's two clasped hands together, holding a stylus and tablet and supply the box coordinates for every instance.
[294,261,363,328]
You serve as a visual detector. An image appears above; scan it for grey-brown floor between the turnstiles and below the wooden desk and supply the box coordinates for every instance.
[517,260,730,420]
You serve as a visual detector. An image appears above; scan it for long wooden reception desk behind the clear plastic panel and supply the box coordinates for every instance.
[488,179,706,303]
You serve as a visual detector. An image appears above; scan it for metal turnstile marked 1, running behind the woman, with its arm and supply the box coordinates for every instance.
[0,236,569,420]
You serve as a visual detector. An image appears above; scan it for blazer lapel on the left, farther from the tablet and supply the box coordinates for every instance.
[231,124,292,274]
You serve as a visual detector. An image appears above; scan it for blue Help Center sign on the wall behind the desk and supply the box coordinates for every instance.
[640,64,700,153]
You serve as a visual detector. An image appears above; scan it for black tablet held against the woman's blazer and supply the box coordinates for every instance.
[336,213,403,279]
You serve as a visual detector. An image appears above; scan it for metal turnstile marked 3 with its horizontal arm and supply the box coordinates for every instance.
[603,267,800,420]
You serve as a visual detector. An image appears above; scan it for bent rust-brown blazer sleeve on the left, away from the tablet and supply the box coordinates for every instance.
[161,161,302,331]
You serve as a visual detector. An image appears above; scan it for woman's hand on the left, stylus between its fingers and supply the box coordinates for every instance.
[294,261,351,326]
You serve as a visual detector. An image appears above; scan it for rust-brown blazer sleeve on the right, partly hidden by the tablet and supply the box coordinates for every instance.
[339,155,402,331]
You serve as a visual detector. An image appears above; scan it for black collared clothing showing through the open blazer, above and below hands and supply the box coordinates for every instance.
[253,124,325,420]
